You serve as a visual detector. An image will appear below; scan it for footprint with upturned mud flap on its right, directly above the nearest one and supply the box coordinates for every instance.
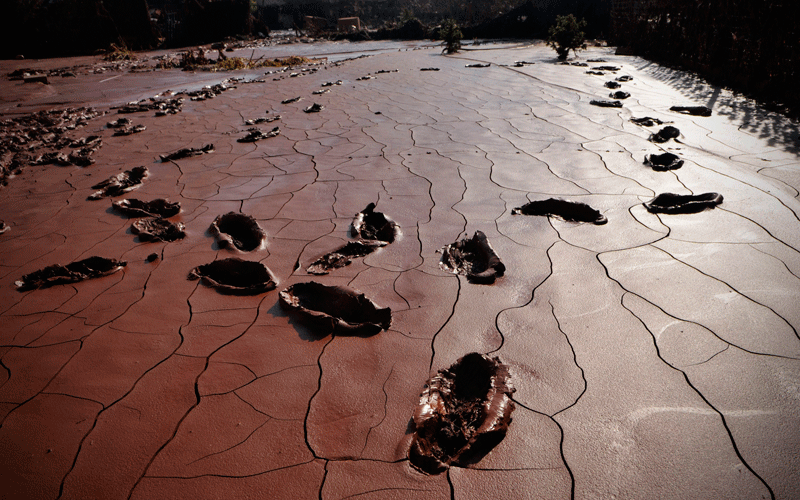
[439,231,506,285]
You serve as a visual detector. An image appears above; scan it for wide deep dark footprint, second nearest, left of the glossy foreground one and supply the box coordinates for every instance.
[280,281,392,336]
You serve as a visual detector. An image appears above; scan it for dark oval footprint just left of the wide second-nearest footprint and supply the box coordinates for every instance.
[189,257,277,295]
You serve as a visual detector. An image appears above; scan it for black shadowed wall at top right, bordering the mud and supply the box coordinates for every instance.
[609,0,800,113]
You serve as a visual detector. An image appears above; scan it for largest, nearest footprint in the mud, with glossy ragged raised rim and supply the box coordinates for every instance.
[408,353,515,474]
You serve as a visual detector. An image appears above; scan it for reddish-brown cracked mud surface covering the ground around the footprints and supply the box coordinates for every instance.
[0,42,800,500]
